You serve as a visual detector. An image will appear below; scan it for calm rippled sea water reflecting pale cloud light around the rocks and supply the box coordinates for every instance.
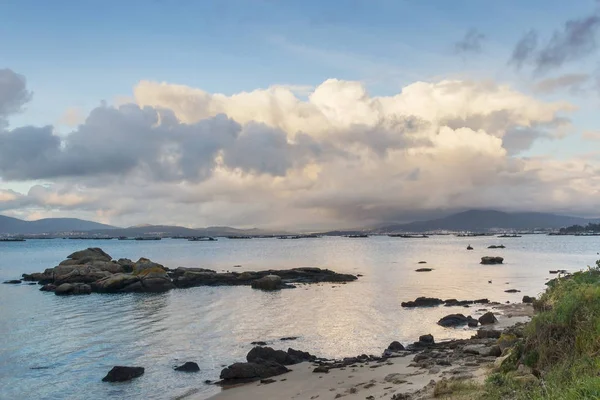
[0,235,600,399]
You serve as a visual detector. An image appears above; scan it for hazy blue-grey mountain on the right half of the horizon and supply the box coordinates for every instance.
[374,210,592,233]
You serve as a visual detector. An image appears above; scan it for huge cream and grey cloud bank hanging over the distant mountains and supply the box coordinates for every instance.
[0,70,600,228]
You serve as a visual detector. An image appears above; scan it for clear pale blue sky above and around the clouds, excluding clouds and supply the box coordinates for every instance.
[0,0,600,222]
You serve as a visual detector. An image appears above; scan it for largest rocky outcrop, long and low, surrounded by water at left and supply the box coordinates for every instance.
[17,248,357,295]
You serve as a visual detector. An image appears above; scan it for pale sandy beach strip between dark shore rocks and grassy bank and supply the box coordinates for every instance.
[199,303,534,400]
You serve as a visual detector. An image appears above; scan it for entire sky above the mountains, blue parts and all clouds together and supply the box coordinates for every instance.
[0,0,600,229]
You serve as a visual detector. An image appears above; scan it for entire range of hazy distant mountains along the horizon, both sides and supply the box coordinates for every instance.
[0,210,599,237]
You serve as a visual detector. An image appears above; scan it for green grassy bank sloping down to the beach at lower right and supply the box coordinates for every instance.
[480,261,600,400]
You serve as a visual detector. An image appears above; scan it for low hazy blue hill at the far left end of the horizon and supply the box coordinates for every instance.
[0,215,115,235]
